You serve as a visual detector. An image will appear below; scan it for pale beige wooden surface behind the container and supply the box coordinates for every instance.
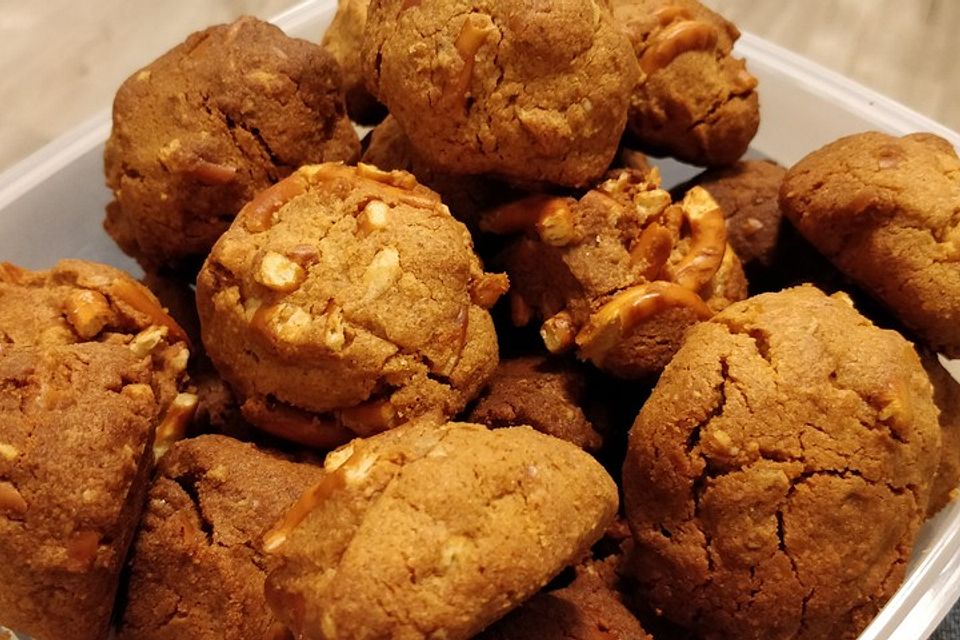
[0,0,960,169]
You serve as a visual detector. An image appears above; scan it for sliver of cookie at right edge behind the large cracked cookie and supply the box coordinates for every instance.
[920,352,960,517]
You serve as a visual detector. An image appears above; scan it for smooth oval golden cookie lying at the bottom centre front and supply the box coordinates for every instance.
[264,422,617,640]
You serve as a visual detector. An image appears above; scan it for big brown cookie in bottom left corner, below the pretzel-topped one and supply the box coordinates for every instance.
[0,342,162,640]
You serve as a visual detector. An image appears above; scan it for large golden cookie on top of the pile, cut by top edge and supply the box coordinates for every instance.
[363,0,637,186]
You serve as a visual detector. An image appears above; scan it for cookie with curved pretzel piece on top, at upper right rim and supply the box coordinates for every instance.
[611,0,760,166]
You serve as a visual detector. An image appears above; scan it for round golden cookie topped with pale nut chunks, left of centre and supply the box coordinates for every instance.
[197,164,507,447]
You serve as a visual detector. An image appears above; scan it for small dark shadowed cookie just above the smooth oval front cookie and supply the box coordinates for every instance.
[466,356,603,451]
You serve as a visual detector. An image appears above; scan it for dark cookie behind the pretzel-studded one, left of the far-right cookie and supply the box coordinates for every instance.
[676,160,787,270]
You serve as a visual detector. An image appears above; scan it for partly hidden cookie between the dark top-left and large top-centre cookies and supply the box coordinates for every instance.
[320,0,386,125]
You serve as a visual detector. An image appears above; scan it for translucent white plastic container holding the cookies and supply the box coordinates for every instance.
[0,0,960,640]
